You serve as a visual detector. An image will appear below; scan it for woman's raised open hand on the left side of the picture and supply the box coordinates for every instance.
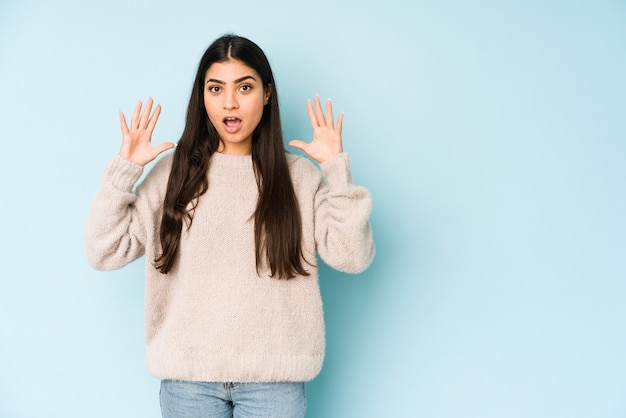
[120,98,176,166]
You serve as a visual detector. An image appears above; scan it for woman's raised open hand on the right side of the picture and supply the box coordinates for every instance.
[289,95,343,163]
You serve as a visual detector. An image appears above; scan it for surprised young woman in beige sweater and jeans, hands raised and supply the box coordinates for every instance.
[86,35,374,418]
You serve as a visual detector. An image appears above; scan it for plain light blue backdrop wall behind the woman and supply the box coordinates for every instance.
[0,0,626,418]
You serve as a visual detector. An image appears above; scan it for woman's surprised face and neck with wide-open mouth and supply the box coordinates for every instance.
[204,59,270,155]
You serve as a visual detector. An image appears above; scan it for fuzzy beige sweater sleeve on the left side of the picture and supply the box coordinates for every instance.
[85,155,154,270]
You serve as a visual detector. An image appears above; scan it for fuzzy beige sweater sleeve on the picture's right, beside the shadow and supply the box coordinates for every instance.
[315,153,375,273]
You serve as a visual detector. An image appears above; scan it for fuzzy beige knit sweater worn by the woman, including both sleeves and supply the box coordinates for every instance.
[86,153,374,382]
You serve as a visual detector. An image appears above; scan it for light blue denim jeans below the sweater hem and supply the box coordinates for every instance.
[160,380,306,418]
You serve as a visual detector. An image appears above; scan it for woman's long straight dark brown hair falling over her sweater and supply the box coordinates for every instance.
[154,35,308,279]
